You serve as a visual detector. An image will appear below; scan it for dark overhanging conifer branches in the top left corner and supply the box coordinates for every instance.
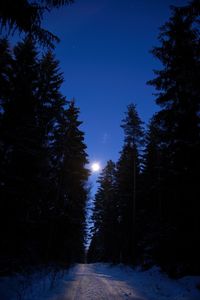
[0,0,73,47]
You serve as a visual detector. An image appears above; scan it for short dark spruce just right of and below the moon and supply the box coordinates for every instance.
[88,160,119,262]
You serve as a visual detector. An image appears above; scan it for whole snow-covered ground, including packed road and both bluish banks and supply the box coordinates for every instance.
[0,263,200,300]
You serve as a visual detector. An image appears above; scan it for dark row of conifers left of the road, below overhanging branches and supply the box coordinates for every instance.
[0,38,89,272]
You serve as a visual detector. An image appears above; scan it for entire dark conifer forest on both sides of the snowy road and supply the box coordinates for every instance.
[0,0,200,277]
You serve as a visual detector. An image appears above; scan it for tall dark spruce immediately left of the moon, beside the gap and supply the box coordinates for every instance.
[51,100,89,262]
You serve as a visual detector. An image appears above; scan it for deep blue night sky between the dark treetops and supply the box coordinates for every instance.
[44,0,187,190]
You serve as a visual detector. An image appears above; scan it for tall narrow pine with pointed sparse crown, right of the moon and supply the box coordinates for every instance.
[117,104,143,263]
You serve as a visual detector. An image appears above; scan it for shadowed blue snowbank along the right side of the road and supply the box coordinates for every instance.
[95,264,200,300]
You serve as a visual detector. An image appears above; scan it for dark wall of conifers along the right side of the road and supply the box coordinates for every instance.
[88,1,200,276]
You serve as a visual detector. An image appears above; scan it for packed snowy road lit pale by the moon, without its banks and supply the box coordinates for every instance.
[57,264,144,300]
